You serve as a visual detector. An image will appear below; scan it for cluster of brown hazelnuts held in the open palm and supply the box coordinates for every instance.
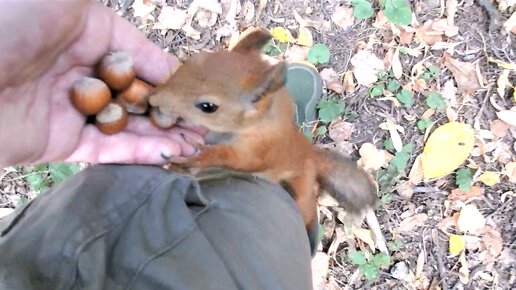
[70,51,177,135]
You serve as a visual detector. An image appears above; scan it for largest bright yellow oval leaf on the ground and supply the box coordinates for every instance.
[421,122,475,178]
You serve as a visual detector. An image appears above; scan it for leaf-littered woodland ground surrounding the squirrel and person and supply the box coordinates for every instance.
[0,0,516,289]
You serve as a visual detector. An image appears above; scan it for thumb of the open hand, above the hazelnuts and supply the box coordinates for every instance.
[102,3,180,84]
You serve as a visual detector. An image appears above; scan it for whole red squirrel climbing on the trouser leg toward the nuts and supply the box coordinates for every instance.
[150,29,377,227]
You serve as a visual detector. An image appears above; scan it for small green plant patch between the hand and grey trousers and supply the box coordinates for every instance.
[23,163,80,192]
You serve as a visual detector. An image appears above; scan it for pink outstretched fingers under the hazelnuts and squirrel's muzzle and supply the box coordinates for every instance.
[65,125,191,164]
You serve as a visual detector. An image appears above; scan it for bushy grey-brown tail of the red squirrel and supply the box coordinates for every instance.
[316,149,378,213]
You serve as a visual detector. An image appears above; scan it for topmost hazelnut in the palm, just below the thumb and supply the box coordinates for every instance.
[97,51,136,91]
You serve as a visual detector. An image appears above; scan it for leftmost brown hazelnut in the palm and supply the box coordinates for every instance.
[70,77,111,115]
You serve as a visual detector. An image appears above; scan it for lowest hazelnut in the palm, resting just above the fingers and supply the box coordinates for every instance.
[95,102,128,135]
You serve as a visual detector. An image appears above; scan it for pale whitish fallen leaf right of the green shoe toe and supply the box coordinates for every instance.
[351,50,385,87]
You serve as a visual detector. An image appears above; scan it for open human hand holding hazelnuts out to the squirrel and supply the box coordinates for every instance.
[0,0,202,168]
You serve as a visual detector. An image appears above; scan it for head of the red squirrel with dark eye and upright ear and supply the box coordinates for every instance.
[150,29,286,132]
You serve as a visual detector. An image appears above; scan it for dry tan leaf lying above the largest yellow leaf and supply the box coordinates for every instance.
[444,53,482,95]
